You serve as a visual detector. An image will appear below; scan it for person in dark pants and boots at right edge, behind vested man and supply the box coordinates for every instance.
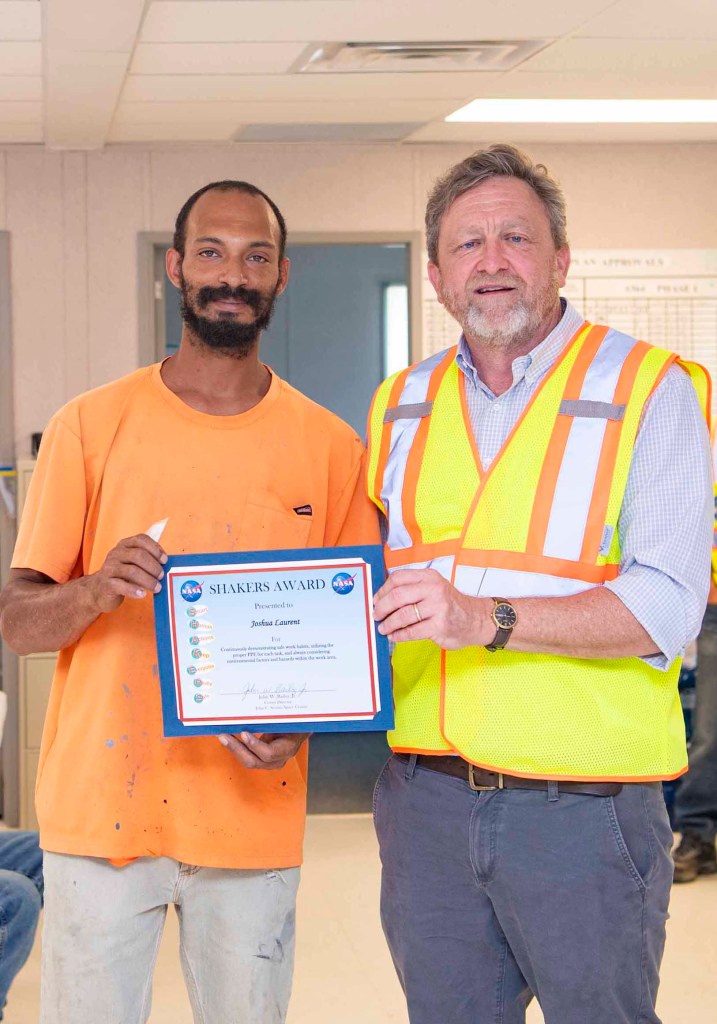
[672,441,717,882]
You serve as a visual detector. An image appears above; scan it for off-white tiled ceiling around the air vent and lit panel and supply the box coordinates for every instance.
[0,0,717,148]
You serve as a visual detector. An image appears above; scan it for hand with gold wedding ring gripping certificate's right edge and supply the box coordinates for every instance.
[374,569,489,650]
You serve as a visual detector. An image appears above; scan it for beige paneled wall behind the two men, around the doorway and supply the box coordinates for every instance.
[0,143,717,456]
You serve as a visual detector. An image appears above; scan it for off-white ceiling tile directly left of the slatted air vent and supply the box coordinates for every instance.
[130,43,304,75]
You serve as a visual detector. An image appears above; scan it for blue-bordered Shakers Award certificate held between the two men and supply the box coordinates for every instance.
[154,545,393,736]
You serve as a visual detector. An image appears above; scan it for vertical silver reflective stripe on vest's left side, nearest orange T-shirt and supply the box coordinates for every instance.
[381,352,446,551]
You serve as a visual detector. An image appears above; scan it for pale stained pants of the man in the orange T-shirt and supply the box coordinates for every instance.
[40,853,299,1024]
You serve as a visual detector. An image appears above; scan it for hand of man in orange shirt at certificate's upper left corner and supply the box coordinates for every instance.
[85,534,167,612]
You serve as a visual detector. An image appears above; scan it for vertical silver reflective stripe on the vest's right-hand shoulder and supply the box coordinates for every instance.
[543,331,636,561]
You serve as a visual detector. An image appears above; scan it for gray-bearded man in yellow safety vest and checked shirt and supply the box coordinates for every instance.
[369,145,712,1024]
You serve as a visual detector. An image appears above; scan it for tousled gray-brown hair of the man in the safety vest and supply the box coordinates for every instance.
[426,143,567,263]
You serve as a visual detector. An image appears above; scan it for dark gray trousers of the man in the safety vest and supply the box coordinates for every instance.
[374,757,672,1024]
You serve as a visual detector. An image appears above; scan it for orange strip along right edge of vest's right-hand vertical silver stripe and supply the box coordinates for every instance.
[580,341,659,562]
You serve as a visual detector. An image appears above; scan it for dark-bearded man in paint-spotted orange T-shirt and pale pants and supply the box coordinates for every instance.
[0,181,378,1024]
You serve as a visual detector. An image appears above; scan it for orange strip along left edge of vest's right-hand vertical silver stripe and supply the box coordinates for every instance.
[525,325,609,555]
